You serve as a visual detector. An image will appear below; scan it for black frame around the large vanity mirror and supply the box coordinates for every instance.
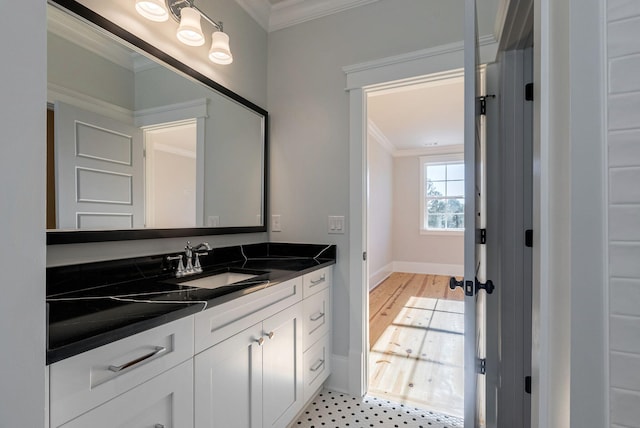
[47,0,269,245]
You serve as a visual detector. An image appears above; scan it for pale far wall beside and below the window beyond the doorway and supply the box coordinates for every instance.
[393,156,464,276]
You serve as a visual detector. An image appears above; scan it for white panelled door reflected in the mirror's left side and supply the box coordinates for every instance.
[54,102,144,229]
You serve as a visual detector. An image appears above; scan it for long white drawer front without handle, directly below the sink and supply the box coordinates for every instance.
[194,278,302,354]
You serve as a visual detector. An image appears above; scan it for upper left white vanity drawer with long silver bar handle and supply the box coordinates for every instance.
[49,316,193,427]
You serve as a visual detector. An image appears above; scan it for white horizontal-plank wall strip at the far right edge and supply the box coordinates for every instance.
[604,0,640,427]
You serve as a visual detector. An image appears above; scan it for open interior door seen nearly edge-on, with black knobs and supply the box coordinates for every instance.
[464,0,493,428]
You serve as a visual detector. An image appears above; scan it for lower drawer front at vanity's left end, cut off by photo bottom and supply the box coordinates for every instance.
[61,360,193,428]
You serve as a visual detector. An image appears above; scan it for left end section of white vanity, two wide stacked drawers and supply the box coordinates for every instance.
[49,316,193,428]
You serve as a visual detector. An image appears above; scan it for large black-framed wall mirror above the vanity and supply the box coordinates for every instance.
[47,0,268,244]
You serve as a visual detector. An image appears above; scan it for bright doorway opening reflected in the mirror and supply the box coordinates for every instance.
[144,120,197,228]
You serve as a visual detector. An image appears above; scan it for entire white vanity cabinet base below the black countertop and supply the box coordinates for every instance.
[48,266,332,428]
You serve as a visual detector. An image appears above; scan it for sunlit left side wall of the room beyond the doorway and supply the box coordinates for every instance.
[367,133,394,289]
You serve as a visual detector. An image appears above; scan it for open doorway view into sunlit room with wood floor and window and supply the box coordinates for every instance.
[366,70,464,418]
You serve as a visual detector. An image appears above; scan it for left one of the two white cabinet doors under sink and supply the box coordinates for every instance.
[194,323,264,428]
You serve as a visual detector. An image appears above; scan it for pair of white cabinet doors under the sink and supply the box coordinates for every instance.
[194,279,303,428]
